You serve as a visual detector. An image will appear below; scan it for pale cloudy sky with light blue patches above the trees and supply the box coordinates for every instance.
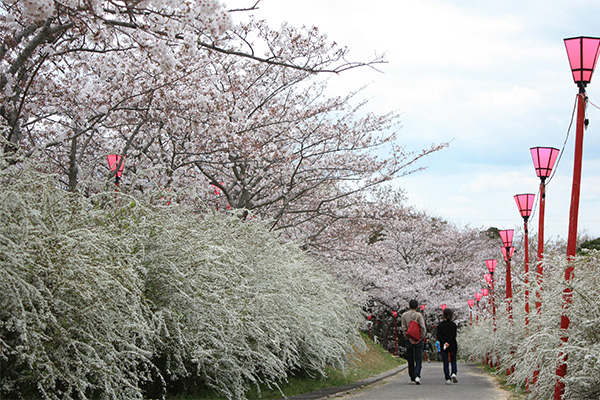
[232,0,600,239]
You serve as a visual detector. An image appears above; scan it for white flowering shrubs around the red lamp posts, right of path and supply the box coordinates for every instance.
[459,251,600,400]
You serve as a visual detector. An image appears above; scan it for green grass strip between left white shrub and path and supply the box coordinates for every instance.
[167,335,406,400]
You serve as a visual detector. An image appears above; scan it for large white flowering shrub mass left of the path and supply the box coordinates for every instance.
[0,161,362,399]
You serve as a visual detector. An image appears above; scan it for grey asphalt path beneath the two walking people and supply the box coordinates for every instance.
[327,363,510,400]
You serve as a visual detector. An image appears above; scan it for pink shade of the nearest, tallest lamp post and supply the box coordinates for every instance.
[565,36,600,87]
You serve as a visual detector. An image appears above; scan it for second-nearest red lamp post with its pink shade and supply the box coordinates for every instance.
[531,147,559,314]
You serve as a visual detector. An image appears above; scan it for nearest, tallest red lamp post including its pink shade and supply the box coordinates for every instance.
[554,36,600,400]
